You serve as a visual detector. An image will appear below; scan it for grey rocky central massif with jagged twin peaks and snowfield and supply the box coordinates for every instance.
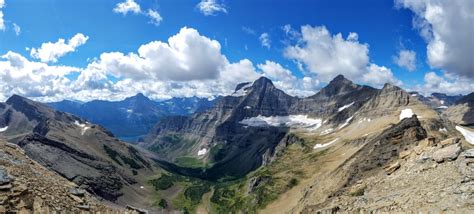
[142,75,436,179]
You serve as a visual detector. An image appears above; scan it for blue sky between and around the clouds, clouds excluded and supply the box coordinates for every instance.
[0,0,474,99]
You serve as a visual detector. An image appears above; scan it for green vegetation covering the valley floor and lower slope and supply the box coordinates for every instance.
[152,134,328,213]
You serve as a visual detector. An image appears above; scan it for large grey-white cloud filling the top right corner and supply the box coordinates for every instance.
[395,0,474,80]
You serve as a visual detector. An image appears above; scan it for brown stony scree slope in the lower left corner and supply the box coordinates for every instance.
[0,141,145,213]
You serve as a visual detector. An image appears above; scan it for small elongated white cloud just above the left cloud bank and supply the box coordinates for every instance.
[30,33,89,62]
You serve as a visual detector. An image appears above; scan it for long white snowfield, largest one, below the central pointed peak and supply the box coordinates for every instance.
[240,115,322,130]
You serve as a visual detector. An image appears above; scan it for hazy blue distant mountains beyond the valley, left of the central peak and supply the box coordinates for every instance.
[48,93,218,142]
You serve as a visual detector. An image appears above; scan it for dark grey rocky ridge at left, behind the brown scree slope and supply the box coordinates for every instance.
[0,95,152,201]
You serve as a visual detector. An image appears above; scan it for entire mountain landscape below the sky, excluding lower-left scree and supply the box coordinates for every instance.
[0,75,474,213]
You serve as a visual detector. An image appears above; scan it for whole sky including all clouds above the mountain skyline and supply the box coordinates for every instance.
[0,0,474,101]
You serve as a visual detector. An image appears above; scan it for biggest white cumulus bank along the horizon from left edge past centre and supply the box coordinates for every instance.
[0,27,319,102]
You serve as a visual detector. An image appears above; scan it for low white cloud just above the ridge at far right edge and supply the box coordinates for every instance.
[415,72,474,95]
